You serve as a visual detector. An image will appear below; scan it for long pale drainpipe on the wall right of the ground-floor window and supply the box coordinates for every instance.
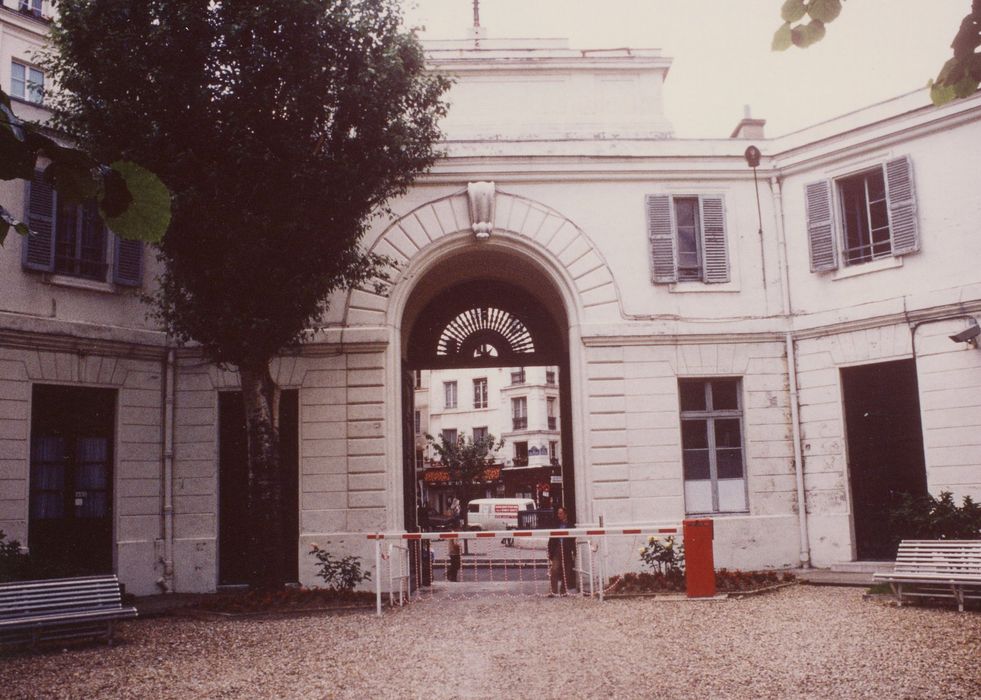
[770,177,811,569]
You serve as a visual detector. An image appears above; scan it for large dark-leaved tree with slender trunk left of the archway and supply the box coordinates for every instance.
[47,0,448,586]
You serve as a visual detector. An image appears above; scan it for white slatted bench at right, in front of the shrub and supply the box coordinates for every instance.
[872,540,981,612]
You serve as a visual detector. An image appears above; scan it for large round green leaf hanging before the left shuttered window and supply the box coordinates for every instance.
[99,161,170,243]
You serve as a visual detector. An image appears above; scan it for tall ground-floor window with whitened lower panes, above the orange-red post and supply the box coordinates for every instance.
[678,379,747,513]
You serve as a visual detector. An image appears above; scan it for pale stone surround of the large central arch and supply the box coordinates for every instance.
[342,190,622,528]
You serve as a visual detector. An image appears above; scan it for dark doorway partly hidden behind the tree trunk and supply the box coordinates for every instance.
[218,389,300,586]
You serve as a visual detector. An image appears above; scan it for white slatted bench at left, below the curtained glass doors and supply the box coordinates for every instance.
[0,576,136,647]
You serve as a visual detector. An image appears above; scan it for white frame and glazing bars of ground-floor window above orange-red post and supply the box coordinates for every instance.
[678,377,749,514]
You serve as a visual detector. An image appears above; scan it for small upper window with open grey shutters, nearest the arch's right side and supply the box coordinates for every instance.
[645,194,729,284]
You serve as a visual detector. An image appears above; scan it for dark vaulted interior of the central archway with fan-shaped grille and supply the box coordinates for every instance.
[401,244,576,529]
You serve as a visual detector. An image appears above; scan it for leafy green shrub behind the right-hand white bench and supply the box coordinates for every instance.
[889,491,981,544]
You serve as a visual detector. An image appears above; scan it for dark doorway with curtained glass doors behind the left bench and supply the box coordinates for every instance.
[28,385,116,576]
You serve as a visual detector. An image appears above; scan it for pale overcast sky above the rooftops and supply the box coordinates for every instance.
[405,0,971,138]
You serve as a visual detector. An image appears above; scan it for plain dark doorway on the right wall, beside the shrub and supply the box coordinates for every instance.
[841,360,927,560]
